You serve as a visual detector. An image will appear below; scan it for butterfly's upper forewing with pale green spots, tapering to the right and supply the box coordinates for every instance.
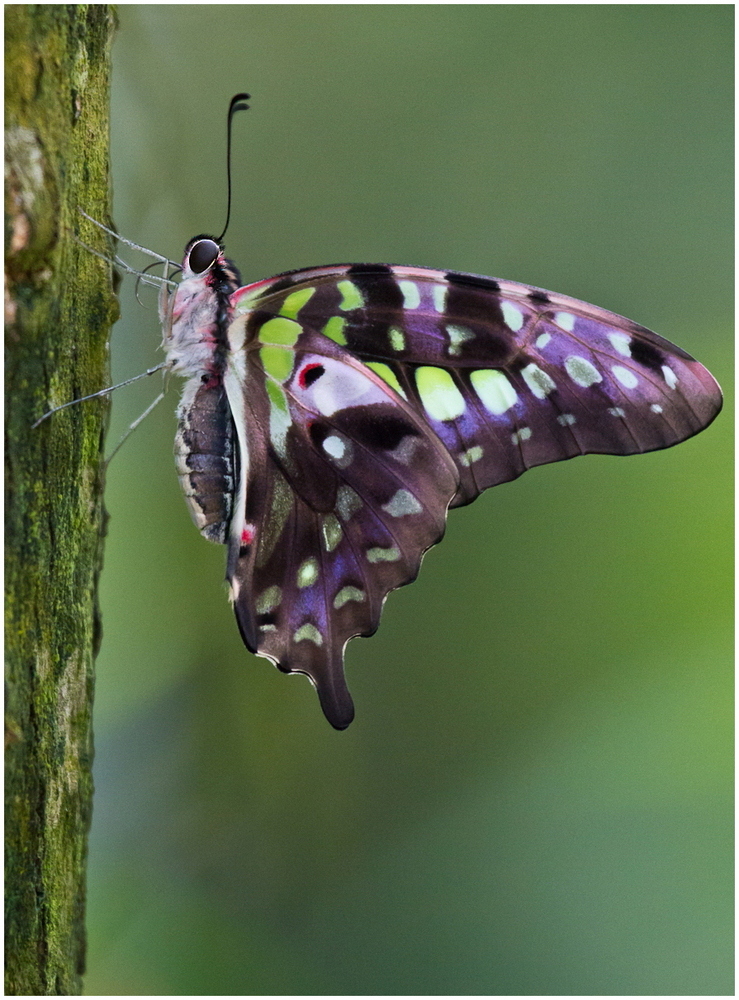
[237,265,721,505]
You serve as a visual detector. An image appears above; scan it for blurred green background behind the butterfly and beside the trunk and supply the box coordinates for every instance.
[87,4,733,995]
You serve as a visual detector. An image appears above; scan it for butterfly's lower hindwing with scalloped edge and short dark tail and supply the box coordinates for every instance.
[226,315,458,728]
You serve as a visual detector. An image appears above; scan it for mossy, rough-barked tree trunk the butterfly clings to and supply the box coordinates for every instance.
[5,4,115,996]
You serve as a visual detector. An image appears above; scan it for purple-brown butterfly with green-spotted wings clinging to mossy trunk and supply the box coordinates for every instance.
[162,235,722,729]
